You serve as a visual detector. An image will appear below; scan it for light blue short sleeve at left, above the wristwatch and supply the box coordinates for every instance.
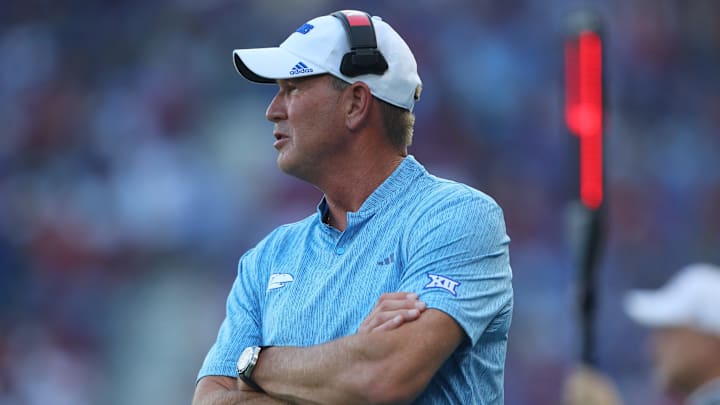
[197,250,262,380]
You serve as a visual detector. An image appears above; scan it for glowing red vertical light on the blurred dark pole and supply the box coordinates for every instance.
[565,31,603,210]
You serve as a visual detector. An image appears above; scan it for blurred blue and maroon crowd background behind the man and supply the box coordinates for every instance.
[0,0,720,405]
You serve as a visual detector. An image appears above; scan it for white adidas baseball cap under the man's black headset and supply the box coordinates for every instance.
[233,10,422,111]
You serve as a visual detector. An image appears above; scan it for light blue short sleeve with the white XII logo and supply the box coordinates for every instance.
[400,186,513,345]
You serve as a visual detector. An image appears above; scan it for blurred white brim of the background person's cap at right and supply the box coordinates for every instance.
[624,290,687,328]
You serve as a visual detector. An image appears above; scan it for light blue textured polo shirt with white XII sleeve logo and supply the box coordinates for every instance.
[198,156,513,405]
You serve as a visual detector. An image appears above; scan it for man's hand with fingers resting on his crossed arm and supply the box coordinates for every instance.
[358,292,427,334]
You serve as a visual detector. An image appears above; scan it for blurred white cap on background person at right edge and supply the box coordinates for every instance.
[624,263,720,336]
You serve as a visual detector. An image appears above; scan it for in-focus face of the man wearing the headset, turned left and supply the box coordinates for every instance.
[265,75,344,182]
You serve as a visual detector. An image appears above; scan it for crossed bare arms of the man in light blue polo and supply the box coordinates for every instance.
[193,293,464,405]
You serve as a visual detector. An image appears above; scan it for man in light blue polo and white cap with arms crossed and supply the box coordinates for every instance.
[194,11,513,404]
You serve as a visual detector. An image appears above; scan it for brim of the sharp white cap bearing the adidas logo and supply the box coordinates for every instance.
[233,48,327,83]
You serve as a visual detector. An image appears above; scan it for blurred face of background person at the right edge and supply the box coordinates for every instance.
[653,327,720,396]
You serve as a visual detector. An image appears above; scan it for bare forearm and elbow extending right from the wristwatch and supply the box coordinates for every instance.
[253,312,461,404]
